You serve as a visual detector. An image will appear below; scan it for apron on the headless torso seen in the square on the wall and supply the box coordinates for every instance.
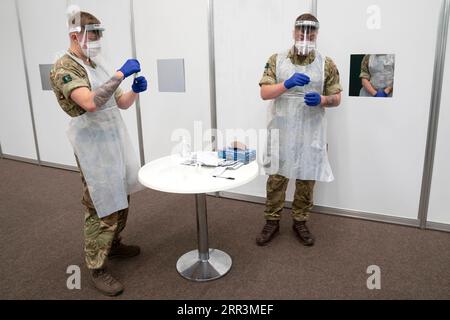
[359,54,395,97]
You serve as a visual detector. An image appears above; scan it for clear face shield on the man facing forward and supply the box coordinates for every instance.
[294,20,319,56]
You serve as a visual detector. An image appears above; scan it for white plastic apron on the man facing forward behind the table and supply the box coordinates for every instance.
[264,51,334,182]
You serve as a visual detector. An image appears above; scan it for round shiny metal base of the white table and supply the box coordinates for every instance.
[177,249,232,281]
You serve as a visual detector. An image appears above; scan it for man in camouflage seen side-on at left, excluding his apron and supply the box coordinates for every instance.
[50,8,147,296]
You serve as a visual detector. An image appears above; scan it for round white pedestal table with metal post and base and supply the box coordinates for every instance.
[139,155,258,281]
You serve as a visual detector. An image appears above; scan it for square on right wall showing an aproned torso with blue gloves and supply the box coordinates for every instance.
[349,54,395,98]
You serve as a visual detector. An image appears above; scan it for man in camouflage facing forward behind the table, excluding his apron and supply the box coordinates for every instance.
[256,14,342,246]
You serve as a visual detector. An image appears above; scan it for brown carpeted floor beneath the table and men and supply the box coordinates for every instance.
[0,159,450,299]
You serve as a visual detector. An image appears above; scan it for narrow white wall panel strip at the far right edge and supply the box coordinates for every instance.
[428,16,450,229]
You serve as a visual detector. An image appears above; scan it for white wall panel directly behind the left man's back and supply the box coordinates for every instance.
[18,0,75,166]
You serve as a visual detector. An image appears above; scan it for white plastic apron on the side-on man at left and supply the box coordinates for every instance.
[67,55,143,218]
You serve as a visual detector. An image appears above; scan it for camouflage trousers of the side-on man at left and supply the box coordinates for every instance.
[76,159,130,269]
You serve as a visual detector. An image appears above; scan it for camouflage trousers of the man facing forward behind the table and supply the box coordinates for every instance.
[264,174,315,221]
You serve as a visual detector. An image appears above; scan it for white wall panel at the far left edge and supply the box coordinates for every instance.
[0,0,37,160]
